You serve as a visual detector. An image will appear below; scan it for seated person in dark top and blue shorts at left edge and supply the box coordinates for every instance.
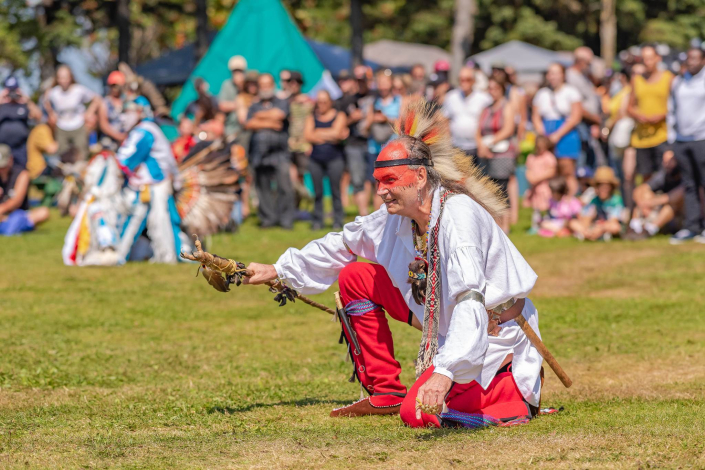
[0,144,49,235]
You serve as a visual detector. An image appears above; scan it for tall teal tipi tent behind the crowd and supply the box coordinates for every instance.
[171,0,339,119]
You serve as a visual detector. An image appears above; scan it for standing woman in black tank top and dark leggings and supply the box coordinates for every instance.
[337,69,372,216]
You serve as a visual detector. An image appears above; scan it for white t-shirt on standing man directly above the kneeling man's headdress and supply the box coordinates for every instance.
[443,88,492,150]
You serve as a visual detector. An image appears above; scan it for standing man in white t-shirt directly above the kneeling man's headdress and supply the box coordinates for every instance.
[443,67,492,157]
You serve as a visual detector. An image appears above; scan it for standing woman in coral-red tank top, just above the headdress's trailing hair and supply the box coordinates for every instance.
[475,78,517,233]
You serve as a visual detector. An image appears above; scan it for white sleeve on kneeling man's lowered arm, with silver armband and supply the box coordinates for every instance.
[433,246,489,384]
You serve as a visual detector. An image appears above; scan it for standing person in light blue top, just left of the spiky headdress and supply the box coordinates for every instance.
[365,70,401,209]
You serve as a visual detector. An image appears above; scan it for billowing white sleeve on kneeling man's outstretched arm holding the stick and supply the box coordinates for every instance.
[274,214,376,294]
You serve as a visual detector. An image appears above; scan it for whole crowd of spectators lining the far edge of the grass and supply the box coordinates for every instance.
[0,40,705,248]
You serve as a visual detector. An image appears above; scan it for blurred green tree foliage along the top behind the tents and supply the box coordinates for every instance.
[0,0,705,77]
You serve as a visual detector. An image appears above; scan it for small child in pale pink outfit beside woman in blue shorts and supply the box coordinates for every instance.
[524,135,558,233]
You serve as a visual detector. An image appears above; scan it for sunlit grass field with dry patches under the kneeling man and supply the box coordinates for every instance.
[0,214,705,468]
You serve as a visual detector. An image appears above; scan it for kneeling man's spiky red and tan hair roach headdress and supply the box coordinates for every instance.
[394,99,507,305]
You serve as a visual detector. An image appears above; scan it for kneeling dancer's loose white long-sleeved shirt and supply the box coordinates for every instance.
[274,186,543,406]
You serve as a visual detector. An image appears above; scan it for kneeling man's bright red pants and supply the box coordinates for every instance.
[338,263,529,427]
